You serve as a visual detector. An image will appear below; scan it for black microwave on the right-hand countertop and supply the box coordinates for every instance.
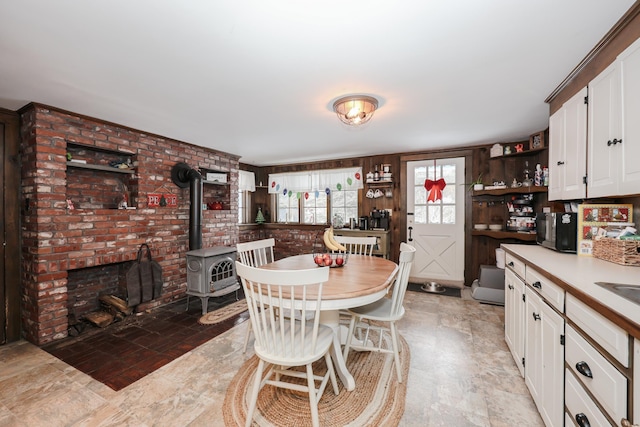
[536,212,578,254]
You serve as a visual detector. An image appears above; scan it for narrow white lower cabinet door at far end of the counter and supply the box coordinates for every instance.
[504,268,525,377]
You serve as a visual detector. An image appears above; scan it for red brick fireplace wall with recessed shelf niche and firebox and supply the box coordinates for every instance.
[20,104,238,345]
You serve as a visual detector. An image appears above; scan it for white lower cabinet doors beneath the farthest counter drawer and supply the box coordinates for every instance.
[524,286,565,427]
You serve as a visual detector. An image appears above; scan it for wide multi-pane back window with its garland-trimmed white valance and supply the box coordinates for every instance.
[269,168,363,224]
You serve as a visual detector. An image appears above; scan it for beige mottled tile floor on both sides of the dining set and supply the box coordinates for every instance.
[0,289,543,427]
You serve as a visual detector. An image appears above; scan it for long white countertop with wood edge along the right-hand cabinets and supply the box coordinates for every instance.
[501,244,640,338]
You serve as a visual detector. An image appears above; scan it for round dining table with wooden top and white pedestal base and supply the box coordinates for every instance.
[260,254,398,390]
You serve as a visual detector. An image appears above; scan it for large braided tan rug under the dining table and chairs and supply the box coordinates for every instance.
[222,337,410,427]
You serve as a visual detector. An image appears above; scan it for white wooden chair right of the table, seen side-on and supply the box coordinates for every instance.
[343,243,416,382]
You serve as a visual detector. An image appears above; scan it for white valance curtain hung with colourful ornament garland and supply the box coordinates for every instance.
[269,168,363,193]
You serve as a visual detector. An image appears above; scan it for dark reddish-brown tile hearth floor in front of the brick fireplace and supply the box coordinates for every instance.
[42,293,248,391]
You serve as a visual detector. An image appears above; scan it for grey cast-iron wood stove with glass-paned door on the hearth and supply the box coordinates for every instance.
[187,246,240,314]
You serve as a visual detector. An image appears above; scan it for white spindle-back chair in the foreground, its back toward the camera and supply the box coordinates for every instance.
[236,262,340,427]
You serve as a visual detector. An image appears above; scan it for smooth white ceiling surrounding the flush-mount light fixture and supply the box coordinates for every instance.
[0,0,633,165]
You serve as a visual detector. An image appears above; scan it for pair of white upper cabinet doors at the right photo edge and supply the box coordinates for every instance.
[588,36,640,198]
